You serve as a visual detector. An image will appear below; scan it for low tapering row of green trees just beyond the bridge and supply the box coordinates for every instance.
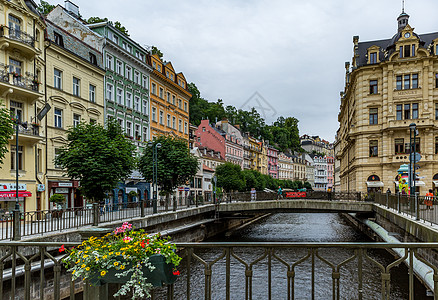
[216,162,312,192]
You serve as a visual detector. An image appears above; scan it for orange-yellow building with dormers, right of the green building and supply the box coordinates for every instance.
[149,54,192,142]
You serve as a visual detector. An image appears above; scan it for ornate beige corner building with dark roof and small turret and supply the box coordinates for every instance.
[336,11,438,195]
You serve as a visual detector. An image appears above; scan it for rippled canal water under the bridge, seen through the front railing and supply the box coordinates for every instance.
[160,213,432,300]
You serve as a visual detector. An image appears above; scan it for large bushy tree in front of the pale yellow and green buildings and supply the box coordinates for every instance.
[55,120,136,202]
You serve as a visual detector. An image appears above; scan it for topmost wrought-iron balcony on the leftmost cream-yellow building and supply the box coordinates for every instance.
[0,26,41,58]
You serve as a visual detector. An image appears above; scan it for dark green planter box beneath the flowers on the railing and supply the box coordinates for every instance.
[88,254,178,287]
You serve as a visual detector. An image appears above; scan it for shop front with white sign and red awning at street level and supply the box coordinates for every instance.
[0,183,32,213]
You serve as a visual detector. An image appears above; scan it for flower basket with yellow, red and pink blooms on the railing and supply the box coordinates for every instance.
[60,222,181,299]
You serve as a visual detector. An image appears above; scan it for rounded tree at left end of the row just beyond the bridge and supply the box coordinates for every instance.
[216,162,245,192]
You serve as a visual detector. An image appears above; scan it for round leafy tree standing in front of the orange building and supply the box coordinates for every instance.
[139,136,198,194]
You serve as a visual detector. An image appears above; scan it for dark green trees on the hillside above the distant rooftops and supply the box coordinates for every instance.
[187,83,302,152]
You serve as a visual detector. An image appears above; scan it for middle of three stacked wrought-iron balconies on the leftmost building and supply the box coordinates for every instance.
[0,72,42,102]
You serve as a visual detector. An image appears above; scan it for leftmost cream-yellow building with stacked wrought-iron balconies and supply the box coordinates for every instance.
[0,0,45,211]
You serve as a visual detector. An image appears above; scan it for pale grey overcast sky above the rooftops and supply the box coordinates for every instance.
[46,0,438,141]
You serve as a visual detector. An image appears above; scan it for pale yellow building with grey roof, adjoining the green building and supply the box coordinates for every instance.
[46,6,105,207]
